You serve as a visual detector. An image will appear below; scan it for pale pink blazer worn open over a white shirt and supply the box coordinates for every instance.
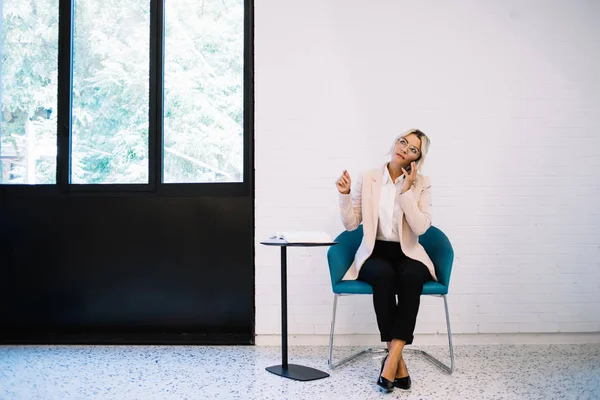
[340,163,437,281]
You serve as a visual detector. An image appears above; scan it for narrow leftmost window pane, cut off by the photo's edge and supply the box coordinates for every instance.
[0,0,58,185]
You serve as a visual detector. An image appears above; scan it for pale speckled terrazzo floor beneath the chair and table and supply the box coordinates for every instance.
[0,344,600,400]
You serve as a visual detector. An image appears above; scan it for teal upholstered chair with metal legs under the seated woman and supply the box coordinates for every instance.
[327,225,454,374]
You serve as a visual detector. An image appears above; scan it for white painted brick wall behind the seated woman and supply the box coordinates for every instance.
[255,0,600,335]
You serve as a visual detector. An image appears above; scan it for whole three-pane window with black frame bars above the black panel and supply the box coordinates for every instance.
[0,0,252,191]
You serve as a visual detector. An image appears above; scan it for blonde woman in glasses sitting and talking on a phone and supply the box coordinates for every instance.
[336,129,437,393]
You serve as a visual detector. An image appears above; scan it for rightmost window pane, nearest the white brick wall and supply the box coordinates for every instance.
[163,0,244,183]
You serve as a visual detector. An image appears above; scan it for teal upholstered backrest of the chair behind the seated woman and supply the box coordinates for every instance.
[327,225,454,287]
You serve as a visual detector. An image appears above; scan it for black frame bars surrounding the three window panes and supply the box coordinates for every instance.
[0,0,254,196]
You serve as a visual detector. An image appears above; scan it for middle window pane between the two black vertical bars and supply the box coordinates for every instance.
[71,0,150,184]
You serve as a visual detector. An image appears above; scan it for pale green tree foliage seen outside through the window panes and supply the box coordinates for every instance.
[1,0,243,183]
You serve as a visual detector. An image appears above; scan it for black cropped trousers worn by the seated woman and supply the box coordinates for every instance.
[358,240,431,344]
